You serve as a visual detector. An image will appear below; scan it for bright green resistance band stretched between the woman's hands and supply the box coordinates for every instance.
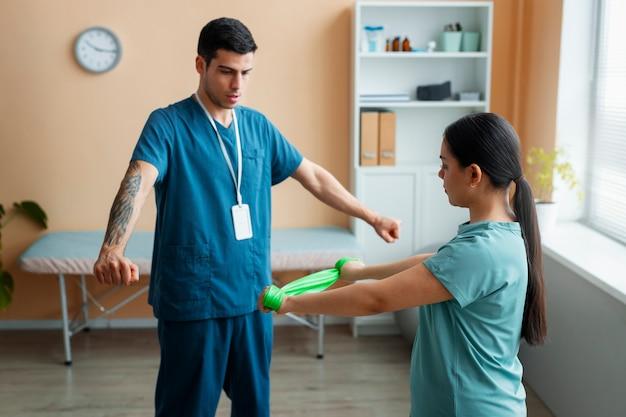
[263,258,360,311]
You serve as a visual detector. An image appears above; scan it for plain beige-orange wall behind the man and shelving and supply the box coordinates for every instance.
[0,0,561,320]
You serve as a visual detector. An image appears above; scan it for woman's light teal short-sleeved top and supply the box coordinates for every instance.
[411,222,528,417]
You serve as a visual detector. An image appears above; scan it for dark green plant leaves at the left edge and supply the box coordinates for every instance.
[0,201,48,310]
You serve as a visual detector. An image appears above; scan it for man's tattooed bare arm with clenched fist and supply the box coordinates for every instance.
[93,161,158,285]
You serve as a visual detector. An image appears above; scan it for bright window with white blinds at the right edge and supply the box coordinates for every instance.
[587,0,626,243]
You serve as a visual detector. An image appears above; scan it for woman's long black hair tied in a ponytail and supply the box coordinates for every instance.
[444,113,547,345]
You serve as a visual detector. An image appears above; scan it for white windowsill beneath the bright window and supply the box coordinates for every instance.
[543,222,626,304]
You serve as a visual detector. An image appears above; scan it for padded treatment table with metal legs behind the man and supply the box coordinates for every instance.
[19,227,361,365]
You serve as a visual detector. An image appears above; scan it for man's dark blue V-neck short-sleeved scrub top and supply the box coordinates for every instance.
[131,96,302,320]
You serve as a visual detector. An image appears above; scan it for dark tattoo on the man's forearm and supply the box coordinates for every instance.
[104,161,141,245]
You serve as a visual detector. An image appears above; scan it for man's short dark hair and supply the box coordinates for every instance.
[198,17,257,65]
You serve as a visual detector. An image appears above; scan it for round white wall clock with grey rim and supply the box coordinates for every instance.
[74,27,122,73]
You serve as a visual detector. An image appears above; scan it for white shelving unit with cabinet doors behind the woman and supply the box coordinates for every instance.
[351,1,493,335]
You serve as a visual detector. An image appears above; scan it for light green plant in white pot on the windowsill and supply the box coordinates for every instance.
[526,147,582,236]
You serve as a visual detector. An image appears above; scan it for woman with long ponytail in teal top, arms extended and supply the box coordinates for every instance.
[260,113,546,417]
